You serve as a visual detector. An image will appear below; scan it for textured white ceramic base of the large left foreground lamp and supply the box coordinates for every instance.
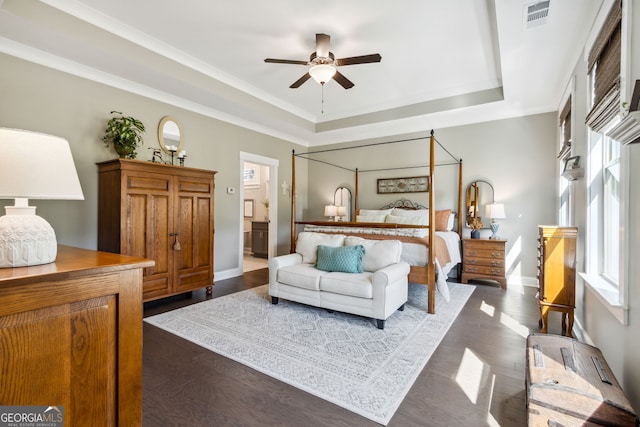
[0,206,58,268]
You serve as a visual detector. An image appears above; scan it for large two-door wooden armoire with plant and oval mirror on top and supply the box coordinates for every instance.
[98,159,216,301]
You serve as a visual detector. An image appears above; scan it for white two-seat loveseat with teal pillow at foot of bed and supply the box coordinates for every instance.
[269,232,409,329]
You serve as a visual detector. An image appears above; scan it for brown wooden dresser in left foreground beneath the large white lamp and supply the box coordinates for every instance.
[0,246,153,426]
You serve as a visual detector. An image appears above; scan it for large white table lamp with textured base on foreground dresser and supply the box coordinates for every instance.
[0,128,84,268]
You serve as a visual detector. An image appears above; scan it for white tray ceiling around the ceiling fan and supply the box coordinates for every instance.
[0,0,603,146]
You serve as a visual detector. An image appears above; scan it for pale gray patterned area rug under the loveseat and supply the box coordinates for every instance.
[145,283,475,425]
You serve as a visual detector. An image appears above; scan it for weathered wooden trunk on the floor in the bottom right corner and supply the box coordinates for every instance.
[526,334,639,427]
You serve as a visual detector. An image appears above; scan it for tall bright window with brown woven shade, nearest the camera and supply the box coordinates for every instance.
[581,0,628,324]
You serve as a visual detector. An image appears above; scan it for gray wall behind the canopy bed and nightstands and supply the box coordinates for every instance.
[304,113,559,285]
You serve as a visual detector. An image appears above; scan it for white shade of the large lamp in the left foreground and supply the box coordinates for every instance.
[0,128,84,200]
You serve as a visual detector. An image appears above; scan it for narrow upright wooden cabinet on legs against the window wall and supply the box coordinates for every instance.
[538,225,578,337]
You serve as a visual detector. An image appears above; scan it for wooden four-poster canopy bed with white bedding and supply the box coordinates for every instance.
[291,130,464,313]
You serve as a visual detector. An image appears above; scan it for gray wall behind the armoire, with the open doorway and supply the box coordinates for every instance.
[0,55,306,277]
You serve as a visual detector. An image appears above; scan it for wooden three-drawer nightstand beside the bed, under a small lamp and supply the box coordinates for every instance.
[462,239,507,289]
